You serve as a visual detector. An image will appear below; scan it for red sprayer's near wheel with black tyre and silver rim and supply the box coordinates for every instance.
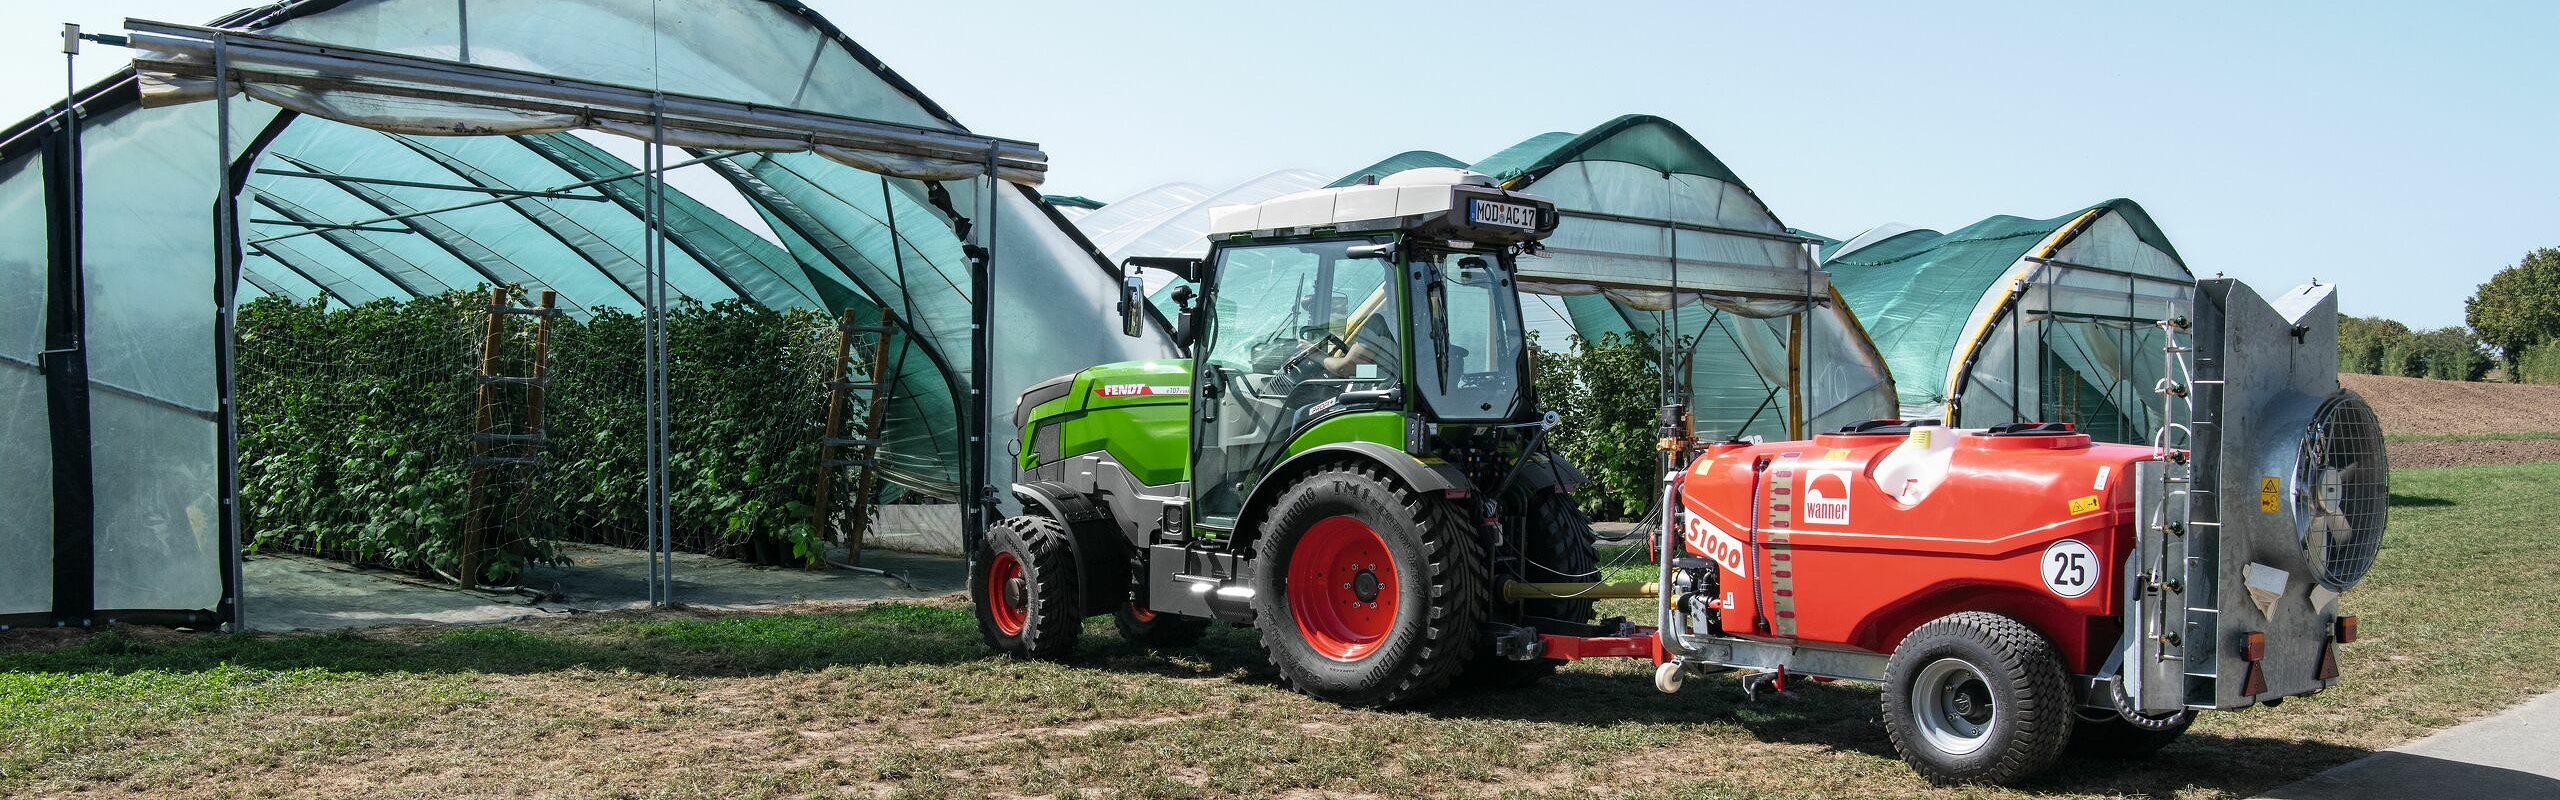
[1884,610,2076,785]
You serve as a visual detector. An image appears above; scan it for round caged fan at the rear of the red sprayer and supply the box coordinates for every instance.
[2294,392,2391,592]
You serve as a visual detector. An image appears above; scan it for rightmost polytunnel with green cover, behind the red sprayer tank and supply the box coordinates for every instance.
[1823,200,2194,441]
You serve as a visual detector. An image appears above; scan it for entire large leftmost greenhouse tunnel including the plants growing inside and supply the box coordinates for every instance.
[0,0,1170,623]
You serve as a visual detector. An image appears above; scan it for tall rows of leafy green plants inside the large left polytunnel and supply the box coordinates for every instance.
[241,292,860,582]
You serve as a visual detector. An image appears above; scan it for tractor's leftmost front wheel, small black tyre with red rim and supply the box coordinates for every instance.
[968,515,1085,662]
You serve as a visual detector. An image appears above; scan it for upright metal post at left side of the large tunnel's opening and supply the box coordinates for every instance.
[213,33,248,631]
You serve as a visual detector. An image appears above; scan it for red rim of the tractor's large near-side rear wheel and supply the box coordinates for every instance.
[1288,515,1398,662]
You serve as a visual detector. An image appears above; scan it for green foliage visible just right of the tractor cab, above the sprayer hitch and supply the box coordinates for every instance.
[1531,331,1661,521]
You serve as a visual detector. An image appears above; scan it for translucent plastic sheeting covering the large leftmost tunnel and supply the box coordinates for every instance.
[0,0,1170,615]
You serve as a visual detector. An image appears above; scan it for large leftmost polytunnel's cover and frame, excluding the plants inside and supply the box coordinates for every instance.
[0,0,1170,626]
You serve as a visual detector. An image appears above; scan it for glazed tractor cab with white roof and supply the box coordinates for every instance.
[1132,169,1556,533]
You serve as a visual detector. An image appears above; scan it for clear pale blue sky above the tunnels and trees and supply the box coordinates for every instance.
[0,0,2560,326]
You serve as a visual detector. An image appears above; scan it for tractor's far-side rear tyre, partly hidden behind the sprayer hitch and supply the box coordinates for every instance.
[1464,492,1600,687]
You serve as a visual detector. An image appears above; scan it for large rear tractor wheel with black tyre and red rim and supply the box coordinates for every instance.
[1254,464,1485,708]
